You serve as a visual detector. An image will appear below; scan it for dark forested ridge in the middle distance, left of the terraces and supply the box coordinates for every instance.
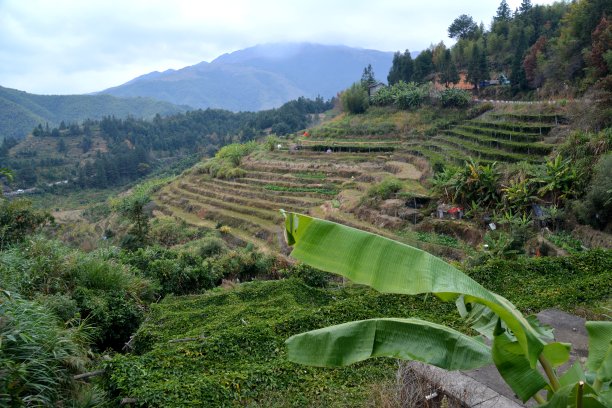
[0,98,331,188]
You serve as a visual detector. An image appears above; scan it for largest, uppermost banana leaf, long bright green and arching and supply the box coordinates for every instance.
[283,212,544,367]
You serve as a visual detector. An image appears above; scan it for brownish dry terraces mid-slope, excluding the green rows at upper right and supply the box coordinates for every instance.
[156,150,419,248]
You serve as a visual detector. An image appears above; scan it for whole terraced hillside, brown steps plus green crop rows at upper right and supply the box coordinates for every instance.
[156,103,565,252]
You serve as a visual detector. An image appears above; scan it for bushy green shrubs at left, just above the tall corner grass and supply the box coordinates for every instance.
[0,237,155,349]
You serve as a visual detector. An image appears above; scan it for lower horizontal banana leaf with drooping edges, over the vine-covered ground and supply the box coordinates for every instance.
[286,319,492,370]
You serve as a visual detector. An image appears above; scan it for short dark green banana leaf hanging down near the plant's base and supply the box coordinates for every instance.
[492,323,548,402]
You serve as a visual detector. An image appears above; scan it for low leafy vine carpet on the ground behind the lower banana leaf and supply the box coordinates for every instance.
[106,279,454,408]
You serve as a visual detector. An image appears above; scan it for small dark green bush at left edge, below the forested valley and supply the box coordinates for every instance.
[0,199,53,251]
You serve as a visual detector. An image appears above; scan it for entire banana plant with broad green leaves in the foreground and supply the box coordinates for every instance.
[283,212,612,408]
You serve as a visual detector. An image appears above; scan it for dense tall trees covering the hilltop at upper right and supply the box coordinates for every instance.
[387,0,612,98]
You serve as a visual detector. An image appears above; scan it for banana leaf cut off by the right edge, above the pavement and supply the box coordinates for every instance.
[585,322,612,382]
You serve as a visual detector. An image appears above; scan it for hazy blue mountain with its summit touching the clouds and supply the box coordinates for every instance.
[101,43,400,111]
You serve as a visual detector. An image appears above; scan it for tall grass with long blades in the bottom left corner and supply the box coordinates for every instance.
[0,291,89,407]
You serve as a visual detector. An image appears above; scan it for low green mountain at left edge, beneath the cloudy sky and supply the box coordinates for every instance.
[0,86,188,140]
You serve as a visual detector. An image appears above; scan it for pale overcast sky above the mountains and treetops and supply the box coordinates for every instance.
[0,0,553,94]
